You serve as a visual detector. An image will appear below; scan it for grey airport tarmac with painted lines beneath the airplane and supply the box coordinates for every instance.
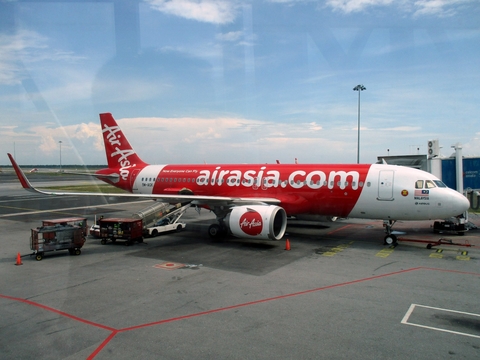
[0,174,480,359]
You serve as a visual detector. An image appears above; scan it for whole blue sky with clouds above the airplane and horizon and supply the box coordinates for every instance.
[0,0,480,165]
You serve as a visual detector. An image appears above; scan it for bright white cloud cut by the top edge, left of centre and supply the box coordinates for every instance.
[147,0,237,24]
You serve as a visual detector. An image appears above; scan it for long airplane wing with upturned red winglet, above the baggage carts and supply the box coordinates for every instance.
[7,154,281,206]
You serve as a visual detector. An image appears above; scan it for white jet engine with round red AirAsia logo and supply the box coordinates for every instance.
[226,205,287,240]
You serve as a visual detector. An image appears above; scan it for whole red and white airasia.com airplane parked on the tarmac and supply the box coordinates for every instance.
[8,113,470,245]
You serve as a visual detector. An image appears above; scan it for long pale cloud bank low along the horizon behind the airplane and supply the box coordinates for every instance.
[5,117,480,165]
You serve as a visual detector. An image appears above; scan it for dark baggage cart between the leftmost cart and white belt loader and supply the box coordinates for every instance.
[99,218,143,246]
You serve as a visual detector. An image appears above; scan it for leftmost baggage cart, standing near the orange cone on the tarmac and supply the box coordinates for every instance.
[30,224,85,261]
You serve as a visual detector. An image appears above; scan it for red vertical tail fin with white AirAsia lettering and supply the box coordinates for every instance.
[100,113,147,169]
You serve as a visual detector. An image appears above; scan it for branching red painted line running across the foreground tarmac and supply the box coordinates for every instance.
[0,266,480,360]
